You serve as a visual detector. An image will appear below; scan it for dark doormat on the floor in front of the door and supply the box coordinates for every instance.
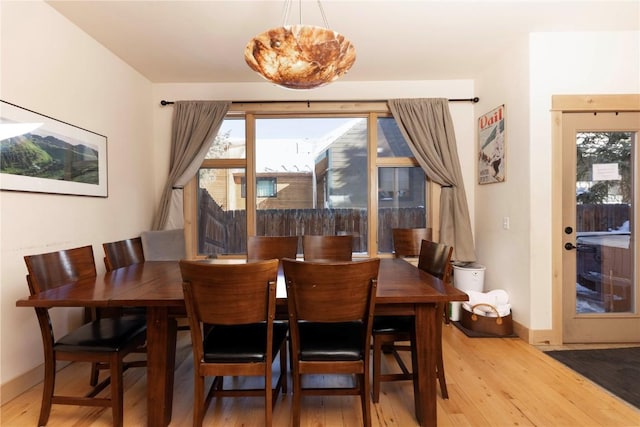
[545,347,640,408]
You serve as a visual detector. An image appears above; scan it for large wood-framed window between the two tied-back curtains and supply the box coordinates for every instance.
[185,103,428,256]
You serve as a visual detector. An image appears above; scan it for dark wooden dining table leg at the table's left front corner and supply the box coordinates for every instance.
[147,307,177,427]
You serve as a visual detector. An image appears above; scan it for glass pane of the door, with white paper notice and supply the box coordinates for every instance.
[576,132,635,313]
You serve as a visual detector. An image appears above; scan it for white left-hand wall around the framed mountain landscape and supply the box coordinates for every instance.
[0,1,156,400]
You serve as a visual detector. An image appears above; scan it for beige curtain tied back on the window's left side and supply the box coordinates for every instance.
[152,101,231,230]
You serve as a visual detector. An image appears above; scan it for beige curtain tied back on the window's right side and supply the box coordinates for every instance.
[389,98,476,262]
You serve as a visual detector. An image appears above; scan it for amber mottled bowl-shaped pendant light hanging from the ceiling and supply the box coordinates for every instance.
[244,0,356,89]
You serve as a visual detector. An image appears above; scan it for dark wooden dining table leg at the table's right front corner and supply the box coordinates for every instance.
[413,304,441,427]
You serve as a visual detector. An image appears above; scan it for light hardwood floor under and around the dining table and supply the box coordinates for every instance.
[0,325,640,427]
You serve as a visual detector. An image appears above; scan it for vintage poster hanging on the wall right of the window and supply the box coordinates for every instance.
[478,104,506,185]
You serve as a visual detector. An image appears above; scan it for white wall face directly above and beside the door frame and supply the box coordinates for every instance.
[529,31,640,329]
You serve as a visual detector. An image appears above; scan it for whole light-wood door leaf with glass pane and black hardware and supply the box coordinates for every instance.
[559,112,640,343]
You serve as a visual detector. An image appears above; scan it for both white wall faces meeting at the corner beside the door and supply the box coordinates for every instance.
[474,32,640,331]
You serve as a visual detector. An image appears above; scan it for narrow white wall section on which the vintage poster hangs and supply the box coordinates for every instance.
[473,37,531,326]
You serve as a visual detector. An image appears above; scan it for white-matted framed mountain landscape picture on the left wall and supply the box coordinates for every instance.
[0,100,109,197]
